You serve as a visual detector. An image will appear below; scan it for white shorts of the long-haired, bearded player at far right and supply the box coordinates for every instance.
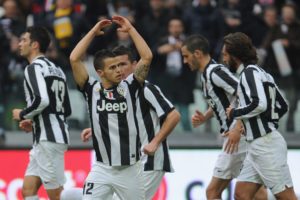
[238,131,293,194]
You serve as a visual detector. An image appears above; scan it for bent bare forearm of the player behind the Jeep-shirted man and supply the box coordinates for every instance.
[143,110,180,155]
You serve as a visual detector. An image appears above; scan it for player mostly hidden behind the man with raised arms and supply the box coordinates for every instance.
[81,46,180,200]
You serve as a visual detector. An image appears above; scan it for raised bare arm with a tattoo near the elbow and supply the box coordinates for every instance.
[112,16,153,83]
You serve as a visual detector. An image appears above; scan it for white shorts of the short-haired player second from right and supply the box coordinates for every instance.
[213,135,247,180]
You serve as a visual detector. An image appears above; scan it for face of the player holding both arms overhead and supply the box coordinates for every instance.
[100,58,122,85]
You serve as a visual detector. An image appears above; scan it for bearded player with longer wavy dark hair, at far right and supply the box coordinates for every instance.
[222,32,296,200]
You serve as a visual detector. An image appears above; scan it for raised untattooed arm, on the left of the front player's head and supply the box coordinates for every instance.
[70,19,112,89]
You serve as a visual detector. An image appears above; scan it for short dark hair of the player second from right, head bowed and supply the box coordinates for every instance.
[183,34,209,54]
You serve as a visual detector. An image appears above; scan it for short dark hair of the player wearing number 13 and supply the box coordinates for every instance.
[26,26,51,53]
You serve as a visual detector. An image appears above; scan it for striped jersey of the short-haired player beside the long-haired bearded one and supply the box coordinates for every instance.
[201,60,238,133]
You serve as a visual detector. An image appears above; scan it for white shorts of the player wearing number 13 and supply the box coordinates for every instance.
[25,141,68,190]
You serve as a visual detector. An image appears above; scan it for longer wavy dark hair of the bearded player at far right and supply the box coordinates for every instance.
[224,32,258,65]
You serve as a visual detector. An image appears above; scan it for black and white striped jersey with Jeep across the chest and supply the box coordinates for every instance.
[82,74,141,166]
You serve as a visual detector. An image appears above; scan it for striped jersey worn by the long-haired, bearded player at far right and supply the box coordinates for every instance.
[231,65,288,141]
